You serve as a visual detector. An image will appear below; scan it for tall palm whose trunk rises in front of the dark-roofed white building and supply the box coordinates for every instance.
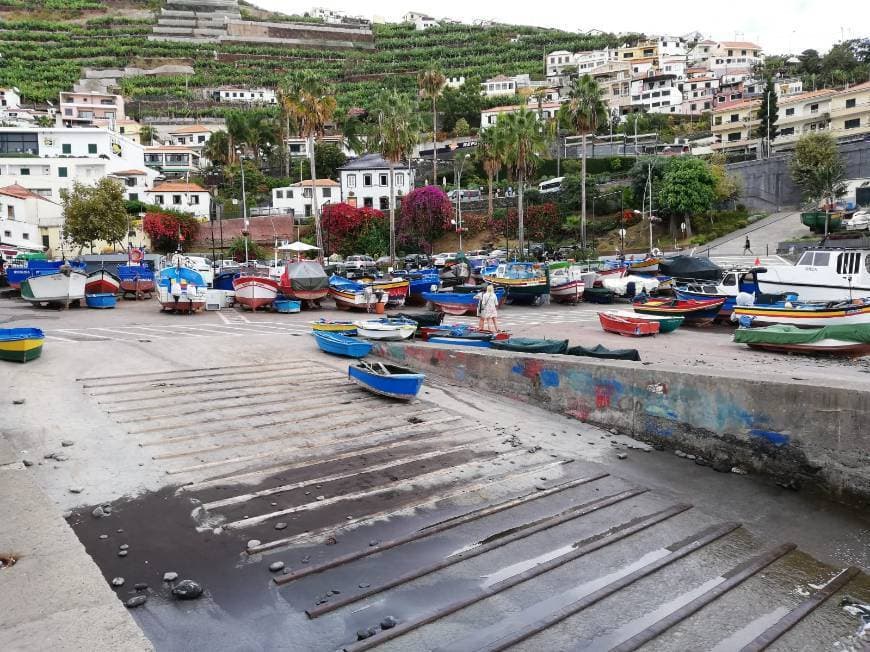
[369,90,422,265]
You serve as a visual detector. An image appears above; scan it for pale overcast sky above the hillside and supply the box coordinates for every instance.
[252,0,870,54]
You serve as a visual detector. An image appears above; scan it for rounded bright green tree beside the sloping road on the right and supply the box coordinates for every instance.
[658,156,716,237]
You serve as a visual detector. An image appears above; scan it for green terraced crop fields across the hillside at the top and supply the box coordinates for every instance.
[0,0,632,113]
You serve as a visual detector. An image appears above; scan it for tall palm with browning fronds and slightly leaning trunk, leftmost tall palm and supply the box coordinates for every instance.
[283,70,336,256]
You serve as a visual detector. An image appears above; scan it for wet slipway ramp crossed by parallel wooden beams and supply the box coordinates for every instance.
[70,361,870,652]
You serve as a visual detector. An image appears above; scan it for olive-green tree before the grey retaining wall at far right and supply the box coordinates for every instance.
[789,132,846,234]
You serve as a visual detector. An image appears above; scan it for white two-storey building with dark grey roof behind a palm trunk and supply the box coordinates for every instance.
[339,154,414,211]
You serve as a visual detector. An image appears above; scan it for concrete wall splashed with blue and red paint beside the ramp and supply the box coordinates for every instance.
[373,342,870,501]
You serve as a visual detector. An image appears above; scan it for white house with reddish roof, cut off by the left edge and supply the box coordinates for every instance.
[0,184,63,253]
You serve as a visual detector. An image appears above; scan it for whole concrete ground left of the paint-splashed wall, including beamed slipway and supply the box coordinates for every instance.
[0,304,870,651]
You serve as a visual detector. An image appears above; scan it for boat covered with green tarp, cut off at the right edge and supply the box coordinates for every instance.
[734,324,870,356]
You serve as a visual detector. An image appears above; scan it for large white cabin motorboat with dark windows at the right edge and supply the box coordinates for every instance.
[756,248,870,301]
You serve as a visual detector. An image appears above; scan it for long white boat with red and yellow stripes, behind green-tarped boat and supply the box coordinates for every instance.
[731,296,870,327]
